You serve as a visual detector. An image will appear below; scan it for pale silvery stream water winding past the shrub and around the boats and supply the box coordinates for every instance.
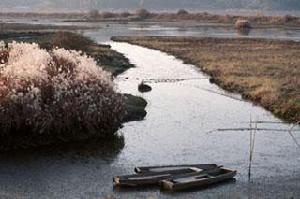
[0,21,300,198]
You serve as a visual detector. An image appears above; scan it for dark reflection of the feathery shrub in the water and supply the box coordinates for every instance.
[0,135,125,163]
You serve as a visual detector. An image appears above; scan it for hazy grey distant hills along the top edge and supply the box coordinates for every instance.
[0,0,300,12]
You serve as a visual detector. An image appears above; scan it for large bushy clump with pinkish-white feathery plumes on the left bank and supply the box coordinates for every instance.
[0,42,124,148]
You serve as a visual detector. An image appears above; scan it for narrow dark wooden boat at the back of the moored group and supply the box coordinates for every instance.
[134,164,218,175]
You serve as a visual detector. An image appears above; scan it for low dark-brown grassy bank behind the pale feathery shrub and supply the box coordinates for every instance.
[0,31,133,75]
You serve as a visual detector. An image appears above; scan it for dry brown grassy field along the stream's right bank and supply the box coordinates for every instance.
[113,37,300,122]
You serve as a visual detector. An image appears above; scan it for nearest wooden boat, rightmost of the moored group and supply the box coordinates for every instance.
[160,167,237,192]
